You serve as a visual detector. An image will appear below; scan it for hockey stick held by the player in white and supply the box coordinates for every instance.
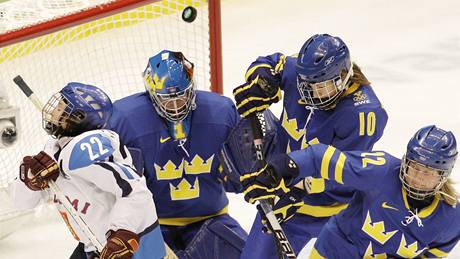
[13,75,104,253]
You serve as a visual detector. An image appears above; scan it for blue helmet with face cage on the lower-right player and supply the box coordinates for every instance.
[399,125,458,200]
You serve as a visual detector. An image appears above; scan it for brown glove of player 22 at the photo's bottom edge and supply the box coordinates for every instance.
[99,229,139,259]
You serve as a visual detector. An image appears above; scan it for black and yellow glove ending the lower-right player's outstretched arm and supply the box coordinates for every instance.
[240,154,299,203]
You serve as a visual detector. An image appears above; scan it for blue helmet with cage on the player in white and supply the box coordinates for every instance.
[42,82,112,138]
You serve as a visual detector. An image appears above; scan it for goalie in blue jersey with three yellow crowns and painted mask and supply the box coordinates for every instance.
[110,50,247,259]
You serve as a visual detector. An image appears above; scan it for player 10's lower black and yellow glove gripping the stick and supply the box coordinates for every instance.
[272,187,308,224]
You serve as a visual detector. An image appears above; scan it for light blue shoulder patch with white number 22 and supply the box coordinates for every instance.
[59,130,120,171]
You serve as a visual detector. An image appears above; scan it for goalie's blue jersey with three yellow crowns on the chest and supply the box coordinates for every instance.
[109,91,239,226]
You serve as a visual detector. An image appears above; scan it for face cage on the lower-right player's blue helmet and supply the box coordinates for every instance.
[399,156,450,200]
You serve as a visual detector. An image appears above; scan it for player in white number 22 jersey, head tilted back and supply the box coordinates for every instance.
[11,83,165,259]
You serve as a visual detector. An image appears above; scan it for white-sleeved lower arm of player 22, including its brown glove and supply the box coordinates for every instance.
[70,161,158,259]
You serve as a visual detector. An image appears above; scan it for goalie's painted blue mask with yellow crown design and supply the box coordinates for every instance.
[143,50,195,122]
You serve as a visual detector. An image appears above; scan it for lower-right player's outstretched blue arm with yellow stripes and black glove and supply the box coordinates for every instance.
[240,144,393,203]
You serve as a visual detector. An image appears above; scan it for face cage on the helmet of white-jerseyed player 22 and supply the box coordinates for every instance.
[42,93,81,138]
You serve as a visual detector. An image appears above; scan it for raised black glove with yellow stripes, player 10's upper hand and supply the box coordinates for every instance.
[233,53,286,117]
